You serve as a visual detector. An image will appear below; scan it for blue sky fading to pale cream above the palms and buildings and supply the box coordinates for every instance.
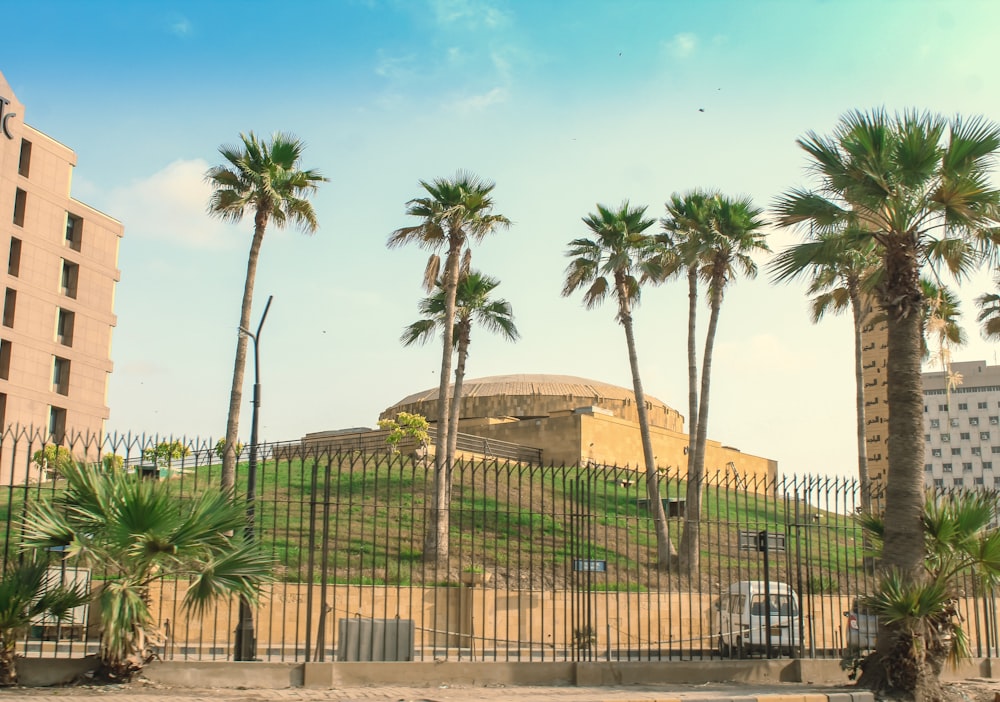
[7,0,1000,475]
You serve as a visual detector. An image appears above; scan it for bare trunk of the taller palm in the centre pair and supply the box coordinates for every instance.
[424,239,461,573]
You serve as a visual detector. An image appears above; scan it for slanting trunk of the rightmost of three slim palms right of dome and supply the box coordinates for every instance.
[679,280,723,576]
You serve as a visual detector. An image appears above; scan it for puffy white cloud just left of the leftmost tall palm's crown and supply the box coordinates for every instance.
[108,159,233,249]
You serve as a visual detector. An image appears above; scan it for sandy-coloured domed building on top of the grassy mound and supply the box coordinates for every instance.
[379,374,777,478]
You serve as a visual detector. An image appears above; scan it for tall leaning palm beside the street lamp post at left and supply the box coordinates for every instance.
[205,132,327,490]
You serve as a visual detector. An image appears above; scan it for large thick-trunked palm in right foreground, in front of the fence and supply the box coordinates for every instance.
[775,110,1000,693]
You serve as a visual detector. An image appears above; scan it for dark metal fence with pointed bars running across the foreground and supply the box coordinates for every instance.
[0,430,1000,661]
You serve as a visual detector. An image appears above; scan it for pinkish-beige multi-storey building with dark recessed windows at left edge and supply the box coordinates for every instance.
[0,74,123,483]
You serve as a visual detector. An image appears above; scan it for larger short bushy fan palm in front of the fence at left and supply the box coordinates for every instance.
[23,462,272,679]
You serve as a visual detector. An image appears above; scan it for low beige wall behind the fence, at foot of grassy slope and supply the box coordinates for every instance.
[139,582,1000,654]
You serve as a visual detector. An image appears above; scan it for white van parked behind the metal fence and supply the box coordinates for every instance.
[715,580,800,658]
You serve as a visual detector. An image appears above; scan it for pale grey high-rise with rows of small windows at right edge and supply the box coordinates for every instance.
[924,361,1000,489]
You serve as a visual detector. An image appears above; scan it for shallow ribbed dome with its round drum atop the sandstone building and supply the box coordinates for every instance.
[380,374,684,431]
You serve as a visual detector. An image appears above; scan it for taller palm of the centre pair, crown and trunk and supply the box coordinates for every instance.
[387,171,510,569]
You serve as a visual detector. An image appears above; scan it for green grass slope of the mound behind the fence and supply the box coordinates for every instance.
[0,455,865,592]
